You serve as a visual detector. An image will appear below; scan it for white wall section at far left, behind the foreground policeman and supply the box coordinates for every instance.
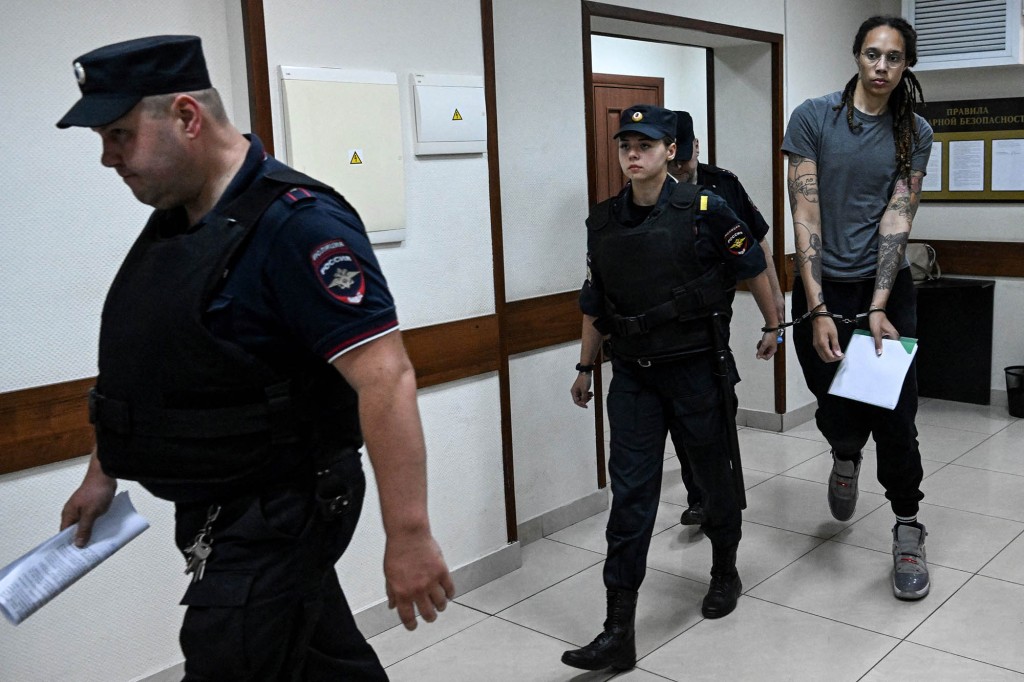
[0,0,236,682]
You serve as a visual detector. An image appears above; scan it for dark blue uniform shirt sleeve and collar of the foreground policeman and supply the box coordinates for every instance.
[204,135,398,365]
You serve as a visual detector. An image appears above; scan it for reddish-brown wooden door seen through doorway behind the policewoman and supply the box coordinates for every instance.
[593,74,665,202]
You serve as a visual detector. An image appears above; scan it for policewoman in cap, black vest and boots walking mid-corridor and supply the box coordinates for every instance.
[562,104,778,670]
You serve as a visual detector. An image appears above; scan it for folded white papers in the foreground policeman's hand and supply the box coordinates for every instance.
[0,492,150,625]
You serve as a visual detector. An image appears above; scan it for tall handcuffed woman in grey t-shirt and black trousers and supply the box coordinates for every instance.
[782,16,932,599]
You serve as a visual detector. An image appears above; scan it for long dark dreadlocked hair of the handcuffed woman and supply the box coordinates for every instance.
[833,16,925,178]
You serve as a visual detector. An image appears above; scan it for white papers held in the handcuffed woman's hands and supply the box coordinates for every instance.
[828,329,918,410]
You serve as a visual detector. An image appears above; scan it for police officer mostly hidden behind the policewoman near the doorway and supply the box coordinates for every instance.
[669,112,785,525]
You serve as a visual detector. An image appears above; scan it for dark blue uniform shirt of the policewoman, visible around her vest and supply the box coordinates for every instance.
[580,176,767,317]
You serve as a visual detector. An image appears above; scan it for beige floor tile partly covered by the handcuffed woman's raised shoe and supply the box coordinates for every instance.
[743,476,888,538]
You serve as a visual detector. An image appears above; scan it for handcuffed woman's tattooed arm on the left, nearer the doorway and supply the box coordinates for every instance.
[787,153,843,363]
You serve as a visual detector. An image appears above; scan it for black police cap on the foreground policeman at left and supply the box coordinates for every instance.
[57,36,212,128]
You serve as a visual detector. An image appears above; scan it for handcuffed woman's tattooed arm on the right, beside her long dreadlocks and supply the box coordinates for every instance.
[869,171,925,353]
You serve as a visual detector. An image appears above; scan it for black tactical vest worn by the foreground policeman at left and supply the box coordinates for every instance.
[89,167,362,502]
